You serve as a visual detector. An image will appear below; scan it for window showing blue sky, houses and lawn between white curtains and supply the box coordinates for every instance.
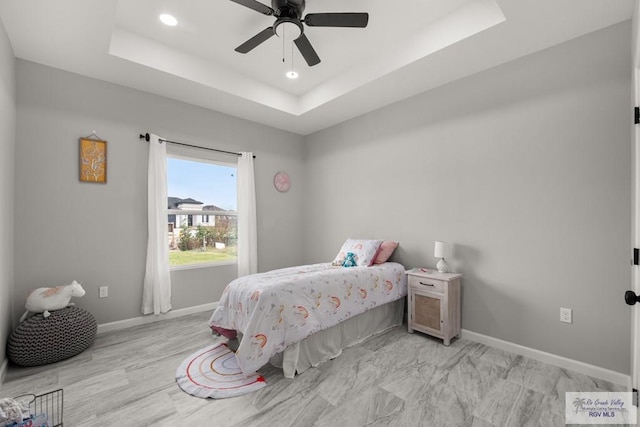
[167,154,238,269]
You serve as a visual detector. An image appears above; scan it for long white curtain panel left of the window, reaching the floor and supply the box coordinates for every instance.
[142,134,171,314]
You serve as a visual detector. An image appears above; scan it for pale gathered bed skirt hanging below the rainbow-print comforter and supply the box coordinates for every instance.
[269,298,406,378]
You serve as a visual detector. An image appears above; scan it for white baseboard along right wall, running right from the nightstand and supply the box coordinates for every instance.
[461,329,631,390]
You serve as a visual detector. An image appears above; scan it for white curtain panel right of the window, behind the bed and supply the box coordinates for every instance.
[238,152,258,277]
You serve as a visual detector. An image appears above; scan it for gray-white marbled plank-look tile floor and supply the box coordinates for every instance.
[0,313,625,427]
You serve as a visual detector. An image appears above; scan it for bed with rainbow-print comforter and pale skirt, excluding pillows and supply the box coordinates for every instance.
[209,251,407,378]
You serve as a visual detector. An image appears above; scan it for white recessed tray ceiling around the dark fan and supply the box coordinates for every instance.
[0,0,633,135]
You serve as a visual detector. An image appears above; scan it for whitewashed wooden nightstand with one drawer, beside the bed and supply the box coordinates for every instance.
[406,269,462,345]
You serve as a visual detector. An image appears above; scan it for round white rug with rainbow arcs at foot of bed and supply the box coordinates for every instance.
[176,343,267,399]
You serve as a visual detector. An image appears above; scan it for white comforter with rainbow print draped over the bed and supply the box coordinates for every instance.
[209,262,407,374]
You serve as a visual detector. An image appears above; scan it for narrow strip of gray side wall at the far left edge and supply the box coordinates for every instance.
[0,17,16,372]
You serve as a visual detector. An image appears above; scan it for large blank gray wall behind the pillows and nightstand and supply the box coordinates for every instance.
[304,23,631,373]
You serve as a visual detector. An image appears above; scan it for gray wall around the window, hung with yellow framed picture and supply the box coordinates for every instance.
[14,60,304,323]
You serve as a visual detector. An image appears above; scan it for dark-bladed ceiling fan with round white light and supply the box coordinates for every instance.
[231,0,369,67]
